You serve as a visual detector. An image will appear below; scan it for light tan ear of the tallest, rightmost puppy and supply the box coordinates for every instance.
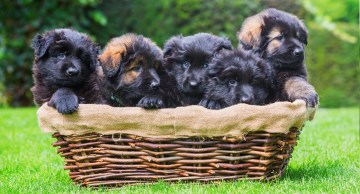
[237,14,264,50]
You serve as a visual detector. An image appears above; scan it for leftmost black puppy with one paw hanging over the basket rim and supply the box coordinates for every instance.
[31,29,101,114]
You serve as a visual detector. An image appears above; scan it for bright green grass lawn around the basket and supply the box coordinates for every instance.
[0,108,360,193]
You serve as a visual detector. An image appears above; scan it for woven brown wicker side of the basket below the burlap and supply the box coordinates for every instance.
[39,101,316,187]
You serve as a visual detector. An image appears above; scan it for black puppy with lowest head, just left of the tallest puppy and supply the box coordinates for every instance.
[199,49,274,109]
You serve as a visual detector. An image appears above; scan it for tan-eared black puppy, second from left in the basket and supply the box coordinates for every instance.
[99,34,177,108]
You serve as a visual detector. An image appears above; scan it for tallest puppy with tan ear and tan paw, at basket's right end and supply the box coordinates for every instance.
[237,8,318,107]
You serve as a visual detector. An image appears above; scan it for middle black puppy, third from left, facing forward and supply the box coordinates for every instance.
[164,33,232,106]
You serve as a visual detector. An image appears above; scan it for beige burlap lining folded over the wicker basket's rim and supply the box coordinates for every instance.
[37,100,316,139]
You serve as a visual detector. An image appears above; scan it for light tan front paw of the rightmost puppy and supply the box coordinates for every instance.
[285,77,316,101]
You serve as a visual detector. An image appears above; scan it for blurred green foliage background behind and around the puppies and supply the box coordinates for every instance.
[0,0,360,107]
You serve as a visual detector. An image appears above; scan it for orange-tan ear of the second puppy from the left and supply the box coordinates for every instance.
[98,46,126,77]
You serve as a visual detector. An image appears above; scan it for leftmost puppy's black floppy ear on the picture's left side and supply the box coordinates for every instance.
[31,34,54,58]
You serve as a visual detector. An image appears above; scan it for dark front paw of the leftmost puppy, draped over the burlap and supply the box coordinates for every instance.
[49,95,79,114]
